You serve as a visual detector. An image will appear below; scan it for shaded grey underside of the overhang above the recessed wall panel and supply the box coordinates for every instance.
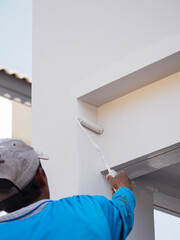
[77,51,180,107]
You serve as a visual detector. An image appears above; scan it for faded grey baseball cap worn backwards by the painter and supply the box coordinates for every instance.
[0,138,48,201]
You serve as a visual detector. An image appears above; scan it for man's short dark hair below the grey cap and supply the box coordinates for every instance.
[0,165,45,213]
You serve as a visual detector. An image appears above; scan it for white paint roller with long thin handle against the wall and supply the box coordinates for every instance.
[76,117,117,177]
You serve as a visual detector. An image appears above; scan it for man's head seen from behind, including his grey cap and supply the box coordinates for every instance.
[0,139,49,212]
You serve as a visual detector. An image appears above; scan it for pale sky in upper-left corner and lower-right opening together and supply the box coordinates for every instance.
[0,0,180,240]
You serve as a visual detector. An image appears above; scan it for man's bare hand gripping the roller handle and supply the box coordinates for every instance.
[106,172,133,194]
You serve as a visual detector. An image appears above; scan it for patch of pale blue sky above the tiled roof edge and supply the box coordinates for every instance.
[0,0,32,78]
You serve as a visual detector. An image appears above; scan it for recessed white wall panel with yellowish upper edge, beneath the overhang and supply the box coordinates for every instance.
[98,72,180,170]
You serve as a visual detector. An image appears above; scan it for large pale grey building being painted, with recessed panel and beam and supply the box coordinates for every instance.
[32,0,180,240]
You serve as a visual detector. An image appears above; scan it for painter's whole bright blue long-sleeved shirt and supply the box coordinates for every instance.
[0,187,135,240]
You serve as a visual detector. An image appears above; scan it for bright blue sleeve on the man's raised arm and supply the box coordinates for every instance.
[94,187,136,240]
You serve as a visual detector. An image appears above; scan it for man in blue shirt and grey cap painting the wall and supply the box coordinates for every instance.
[0,139,135,240]
